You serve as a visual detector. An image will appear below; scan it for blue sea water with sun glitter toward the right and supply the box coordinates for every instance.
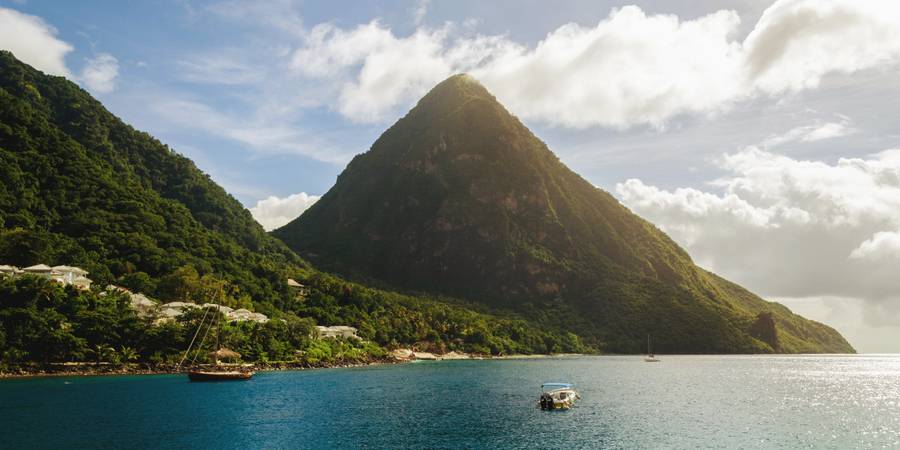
[0,356,900,449]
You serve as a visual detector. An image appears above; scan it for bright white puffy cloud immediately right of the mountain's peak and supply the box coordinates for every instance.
[473,6,745,127]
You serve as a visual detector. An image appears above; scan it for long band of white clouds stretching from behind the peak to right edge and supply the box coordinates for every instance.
[292,0,900,127]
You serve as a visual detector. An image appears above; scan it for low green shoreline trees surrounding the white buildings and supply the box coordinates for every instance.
[0,273,585,370]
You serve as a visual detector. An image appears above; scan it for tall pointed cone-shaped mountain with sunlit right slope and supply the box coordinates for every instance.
[274,75,853,353]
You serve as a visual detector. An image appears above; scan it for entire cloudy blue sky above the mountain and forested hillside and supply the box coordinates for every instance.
[0,0,900,351]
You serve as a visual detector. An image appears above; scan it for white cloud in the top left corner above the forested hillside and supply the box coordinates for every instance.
[0,8,73,77]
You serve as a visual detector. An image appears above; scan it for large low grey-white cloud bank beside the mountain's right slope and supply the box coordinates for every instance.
[616,148,900,342]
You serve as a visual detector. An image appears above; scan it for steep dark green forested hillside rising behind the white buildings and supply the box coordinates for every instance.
[0,52,305,311]
